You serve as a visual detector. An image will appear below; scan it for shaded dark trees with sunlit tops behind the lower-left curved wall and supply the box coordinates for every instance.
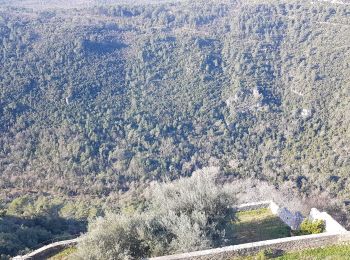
[0,196,97,259]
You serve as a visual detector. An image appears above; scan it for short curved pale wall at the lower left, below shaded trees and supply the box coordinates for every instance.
[12,238,79,260]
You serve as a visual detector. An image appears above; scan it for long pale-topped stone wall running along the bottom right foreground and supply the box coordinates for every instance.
[149,233,350,260]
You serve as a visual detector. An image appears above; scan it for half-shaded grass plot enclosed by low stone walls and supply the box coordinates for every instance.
[227,209,291,245]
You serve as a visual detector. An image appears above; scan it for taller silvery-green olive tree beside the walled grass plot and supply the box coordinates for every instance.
[149,167,235,252]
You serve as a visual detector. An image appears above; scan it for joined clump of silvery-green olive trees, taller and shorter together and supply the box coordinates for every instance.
[78,168,233,259]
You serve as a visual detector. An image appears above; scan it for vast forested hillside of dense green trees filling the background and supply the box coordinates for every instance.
[0,0,350,256]
